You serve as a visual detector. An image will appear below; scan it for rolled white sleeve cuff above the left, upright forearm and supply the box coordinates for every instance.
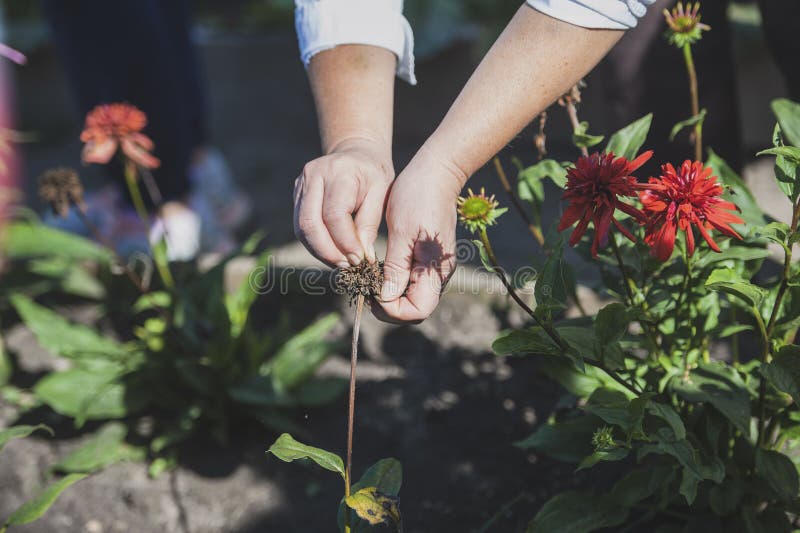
[294,0,417,85]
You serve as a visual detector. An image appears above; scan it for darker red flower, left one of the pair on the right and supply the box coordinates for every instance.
[558,150,653,256]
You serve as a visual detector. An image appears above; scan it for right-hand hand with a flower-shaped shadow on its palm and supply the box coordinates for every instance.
[373,146,466,323]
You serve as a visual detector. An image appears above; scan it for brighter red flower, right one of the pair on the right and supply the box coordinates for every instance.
[639,159,744,261]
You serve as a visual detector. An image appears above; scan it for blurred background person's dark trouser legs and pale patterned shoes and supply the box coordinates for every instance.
[42,0,251,260]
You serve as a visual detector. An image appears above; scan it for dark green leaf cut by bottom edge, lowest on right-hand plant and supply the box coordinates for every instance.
[527,492,628,533]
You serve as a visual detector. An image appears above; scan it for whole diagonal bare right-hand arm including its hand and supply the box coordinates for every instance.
[382,6,623,321]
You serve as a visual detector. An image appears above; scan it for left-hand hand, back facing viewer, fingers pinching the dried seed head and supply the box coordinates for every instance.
[294,138,394,267]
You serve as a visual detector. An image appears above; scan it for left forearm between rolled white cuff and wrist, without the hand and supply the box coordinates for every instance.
[308,45,397,154]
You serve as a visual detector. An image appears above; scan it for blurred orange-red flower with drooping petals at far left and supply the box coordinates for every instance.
[81,104,161,168]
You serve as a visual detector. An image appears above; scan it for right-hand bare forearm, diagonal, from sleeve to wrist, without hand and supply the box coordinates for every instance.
[423,6,623,185]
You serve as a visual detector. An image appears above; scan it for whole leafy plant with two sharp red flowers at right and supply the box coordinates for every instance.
[472,6,800,533]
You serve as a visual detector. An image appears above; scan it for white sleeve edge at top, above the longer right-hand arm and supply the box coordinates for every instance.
[527,0,656,30]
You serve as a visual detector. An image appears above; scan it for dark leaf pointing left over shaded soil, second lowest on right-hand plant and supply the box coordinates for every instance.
[514,416,603,464]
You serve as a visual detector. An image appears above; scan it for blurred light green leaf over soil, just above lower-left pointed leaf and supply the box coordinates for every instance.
[53,422,145,474]
